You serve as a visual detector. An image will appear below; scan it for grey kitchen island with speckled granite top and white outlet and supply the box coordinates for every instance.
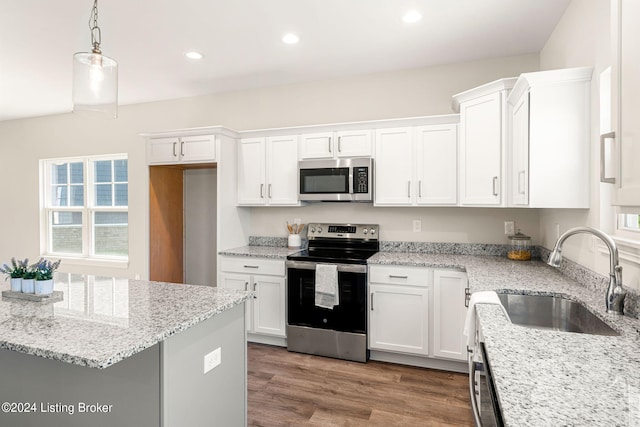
[0,274,252,427]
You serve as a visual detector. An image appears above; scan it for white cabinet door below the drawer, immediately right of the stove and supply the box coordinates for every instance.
[369,284,429,356]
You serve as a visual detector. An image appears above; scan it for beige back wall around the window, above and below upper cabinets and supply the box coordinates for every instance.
[0,54,539,278]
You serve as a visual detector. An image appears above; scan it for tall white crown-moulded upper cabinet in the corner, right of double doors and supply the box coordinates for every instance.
[453,78,516,206]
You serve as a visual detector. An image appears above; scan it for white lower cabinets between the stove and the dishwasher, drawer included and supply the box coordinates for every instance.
[369,265,467,361]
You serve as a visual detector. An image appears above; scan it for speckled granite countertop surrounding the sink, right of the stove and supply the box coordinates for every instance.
[369,252,640,426]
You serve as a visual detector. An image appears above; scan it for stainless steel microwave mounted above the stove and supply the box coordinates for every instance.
[298,157,373,202]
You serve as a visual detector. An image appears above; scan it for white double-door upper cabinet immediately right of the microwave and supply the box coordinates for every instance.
[374,123,457,206]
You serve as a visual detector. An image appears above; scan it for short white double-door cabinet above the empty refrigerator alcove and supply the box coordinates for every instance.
[147,135,217,165]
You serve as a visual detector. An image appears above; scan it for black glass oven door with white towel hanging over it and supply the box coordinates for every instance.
[287,261,367,334]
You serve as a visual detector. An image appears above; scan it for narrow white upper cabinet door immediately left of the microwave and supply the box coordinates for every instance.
[266,135,299,205]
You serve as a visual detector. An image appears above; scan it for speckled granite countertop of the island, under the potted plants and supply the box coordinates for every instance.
[0,276,253,369]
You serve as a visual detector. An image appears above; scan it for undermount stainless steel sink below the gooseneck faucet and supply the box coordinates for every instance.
[498,293,620,336]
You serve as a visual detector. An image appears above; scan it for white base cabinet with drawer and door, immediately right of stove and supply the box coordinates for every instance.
[369,265,429,356]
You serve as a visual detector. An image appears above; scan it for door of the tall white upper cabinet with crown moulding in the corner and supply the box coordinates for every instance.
[460,92,503,205]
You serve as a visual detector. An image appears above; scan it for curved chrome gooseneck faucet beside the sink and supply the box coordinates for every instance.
[547,227,627,314]
